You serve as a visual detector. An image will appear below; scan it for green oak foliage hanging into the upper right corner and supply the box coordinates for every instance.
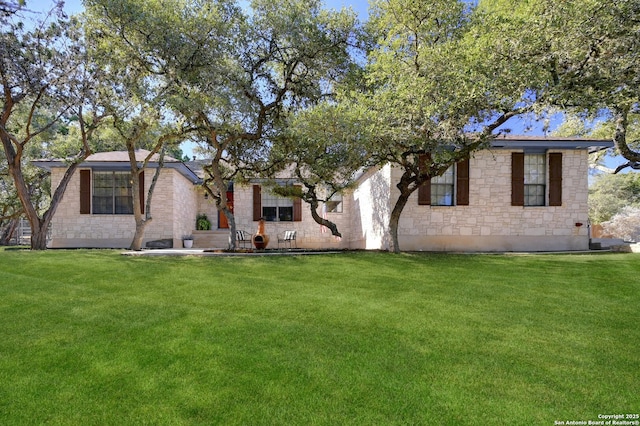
[479,0,640,162]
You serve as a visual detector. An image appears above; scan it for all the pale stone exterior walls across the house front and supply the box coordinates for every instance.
[50,149,589,251]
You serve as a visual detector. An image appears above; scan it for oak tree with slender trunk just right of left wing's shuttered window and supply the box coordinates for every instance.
[84,0,208,250]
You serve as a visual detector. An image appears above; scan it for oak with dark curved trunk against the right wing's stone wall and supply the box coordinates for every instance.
[350,0,537,251]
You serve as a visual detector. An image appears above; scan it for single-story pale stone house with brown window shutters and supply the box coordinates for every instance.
[35,136,613,251]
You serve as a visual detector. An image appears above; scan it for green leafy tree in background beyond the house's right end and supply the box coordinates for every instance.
[589,173,640,223]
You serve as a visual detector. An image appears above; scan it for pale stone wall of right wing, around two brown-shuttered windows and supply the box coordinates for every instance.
[391,150,589,251]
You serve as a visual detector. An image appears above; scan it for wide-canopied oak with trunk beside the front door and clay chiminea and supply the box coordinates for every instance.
[86,0,355,246]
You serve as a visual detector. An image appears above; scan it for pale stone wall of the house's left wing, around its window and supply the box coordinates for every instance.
[49,168,196,248]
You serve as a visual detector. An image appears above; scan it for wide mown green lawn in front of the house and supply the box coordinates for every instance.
[0,250,640,425]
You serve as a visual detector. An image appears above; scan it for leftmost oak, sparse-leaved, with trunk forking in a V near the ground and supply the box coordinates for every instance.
[0,6,102,250]
